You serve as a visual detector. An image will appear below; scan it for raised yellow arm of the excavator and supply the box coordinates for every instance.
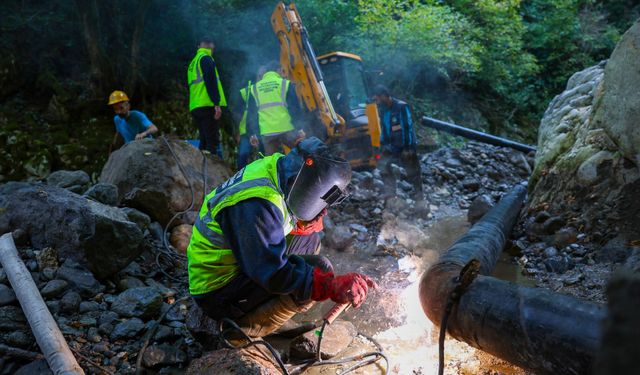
[271,3,345,139]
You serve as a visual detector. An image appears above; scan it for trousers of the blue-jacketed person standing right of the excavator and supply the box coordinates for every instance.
[378,151,424,200]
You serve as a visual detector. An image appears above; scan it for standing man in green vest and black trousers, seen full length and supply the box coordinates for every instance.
[187,37,227,157]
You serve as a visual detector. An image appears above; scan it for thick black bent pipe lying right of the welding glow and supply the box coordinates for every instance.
[419,186,605,375]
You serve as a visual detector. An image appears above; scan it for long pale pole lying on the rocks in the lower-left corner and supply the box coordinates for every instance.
[0,233,84,375]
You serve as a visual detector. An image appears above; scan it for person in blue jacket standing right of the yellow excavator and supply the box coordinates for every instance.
[373,85,424,200]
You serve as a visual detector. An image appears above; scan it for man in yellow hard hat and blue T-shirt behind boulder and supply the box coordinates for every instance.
[108,90,158,147]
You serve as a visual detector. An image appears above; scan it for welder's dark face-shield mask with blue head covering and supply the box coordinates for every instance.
[284,137,351,221]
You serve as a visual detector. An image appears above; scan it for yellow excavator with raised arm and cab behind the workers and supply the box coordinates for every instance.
[271,3,380,169]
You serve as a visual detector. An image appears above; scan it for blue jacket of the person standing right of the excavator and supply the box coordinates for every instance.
[378,98,416,154]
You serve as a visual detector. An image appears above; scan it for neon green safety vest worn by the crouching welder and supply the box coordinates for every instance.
[187,153,294,295]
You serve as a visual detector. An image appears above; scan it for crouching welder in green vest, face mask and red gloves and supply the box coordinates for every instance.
[187,138,376,337]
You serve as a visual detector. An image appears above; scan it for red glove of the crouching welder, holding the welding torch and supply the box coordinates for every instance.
[311,267,378,307]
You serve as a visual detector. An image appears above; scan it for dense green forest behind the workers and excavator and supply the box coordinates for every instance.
[0,0,640,182]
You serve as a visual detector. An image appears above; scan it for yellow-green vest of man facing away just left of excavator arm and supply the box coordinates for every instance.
[252,72,293,135]
